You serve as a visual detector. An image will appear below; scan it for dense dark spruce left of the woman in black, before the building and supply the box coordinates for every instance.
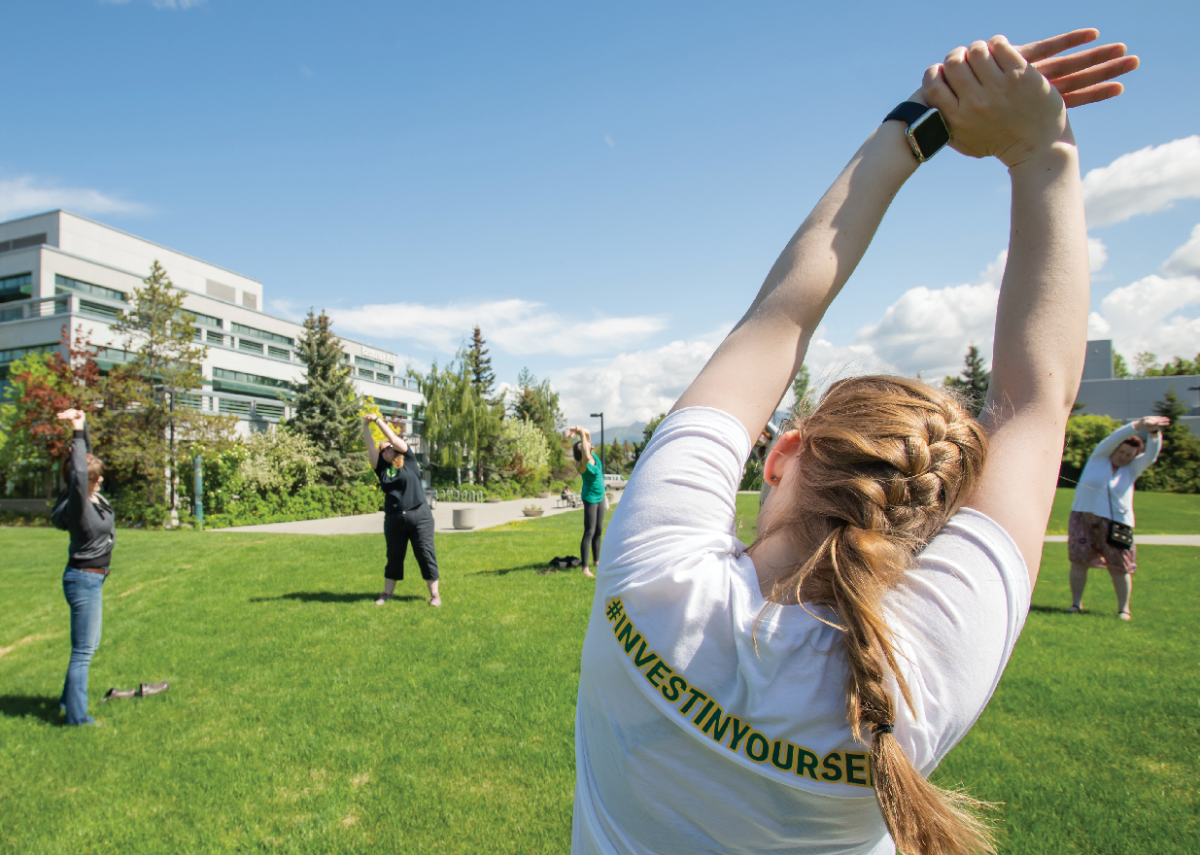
[289,309,367,486]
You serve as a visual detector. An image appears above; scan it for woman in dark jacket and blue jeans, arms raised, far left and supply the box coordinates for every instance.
[59,409,114,724]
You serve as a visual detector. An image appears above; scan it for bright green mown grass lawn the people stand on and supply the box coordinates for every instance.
[0,494,1200,855]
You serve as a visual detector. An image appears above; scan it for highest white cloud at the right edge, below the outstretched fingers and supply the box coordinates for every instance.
[1084,136,1200,228]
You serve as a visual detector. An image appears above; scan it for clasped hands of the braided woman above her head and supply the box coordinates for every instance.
[914,29,1138,168]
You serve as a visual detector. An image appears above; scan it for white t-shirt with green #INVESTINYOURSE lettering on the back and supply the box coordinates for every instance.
[571,407,1030,855]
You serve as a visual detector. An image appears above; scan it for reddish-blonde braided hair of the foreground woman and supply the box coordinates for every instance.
[760,376,994,855]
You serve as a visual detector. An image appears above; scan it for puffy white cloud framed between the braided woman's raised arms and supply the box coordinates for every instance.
[857,250,1008,378]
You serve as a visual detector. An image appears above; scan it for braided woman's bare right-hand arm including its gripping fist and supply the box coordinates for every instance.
[925,36,1088,580]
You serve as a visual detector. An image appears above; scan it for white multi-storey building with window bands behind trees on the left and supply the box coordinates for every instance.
[0,210,422,434]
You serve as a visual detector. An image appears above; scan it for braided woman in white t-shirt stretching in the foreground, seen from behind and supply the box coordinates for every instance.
[571,31,1136,855]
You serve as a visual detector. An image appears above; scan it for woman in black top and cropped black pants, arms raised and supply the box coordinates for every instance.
[362,414,442,605]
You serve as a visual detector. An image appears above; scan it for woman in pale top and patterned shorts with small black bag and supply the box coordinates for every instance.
[1067,415,1171,621]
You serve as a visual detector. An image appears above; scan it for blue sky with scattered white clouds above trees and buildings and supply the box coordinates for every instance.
[0,0,1200,424]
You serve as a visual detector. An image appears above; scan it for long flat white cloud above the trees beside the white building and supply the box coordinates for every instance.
[329,299,666,355]
